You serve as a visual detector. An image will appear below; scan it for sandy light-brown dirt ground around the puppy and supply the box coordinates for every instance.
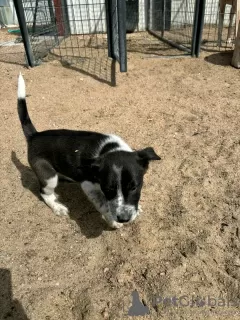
[0,28,240,320]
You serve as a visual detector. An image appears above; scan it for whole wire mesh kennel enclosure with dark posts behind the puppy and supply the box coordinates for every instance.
[14,0,238,71]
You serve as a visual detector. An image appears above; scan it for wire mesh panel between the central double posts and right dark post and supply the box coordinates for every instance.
[123,0,196,56]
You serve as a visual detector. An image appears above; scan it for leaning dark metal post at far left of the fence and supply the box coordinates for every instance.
[13,0,35,67]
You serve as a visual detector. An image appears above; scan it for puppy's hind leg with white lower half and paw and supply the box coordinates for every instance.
[32,159,68,216]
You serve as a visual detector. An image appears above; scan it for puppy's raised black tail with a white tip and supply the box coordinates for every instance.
[18,73,37,140]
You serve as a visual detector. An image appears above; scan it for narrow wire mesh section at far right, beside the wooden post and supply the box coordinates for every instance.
[201,0,237,51]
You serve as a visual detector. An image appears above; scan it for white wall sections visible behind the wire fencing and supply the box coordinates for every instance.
[8,0,234,34]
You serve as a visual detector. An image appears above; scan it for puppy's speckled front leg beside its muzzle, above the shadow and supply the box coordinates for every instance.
[81,181,123,229]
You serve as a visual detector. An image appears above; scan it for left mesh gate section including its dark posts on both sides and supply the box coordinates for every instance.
[14,0,127,72]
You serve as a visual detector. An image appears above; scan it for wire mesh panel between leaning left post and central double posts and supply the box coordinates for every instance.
[23,0,107,61]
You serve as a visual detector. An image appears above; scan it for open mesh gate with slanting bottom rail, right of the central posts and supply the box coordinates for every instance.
[140,0,204,56]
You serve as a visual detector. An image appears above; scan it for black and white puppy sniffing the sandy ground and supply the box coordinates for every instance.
[18,74,160,228]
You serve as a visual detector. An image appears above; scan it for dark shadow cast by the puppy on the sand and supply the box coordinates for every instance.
[11,151,112,238]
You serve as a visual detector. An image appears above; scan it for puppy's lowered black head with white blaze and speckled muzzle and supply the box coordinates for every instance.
[85,147,160,223]
